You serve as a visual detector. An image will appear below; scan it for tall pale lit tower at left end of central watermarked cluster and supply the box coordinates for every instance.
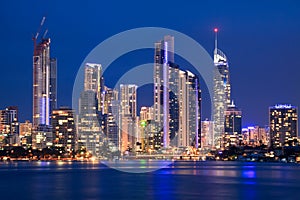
[77,63,104,157]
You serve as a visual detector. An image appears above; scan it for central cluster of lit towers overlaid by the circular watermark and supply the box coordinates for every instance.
[77,36,201,157]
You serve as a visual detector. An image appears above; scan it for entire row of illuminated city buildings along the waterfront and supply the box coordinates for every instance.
[0,25,298,158]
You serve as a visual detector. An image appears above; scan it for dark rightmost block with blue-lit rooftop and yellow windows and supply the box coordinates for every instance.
[269,104,298,148]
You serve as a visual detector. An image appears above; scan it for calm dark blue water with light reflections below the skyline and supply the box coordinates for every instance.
[0,161,300,200]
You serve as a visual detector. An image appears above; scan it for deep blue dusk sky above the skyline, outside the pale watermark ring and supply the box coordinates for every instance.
[0,0,300,125]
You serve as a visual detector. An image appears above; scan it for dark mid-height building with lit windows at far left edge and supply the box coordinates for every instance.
[0,106,19,146]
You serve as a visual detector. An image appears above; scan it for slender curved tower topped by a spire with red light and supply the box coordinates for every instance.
[213,29,231,148]
